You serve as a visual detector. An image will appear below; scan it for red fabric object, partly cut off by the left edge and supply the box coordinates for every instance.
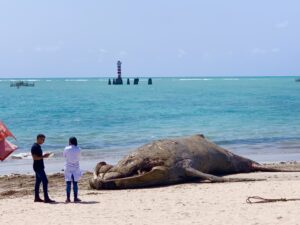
[0,121,18,161]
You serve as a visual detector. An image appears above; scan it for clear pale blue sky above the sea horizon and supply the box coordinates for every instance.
[0,0,300,78]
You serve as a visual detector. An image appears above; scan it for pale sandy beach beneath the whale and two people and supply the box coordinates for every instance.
[0,162,300,225]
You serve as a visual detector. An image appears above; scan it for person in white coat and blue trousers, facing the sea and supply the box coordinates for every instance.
[63,137,81,203]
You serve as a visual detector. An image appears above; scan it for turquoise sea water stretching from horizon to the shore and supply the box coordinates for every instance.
[0,77,300,173]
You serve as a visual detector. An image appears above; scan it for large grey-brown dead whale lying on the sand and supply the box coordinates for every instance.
[90,134,296,189]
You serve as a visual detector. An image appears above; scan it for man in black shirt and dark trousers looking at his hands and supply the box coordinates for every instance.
[31,134,55,203]
